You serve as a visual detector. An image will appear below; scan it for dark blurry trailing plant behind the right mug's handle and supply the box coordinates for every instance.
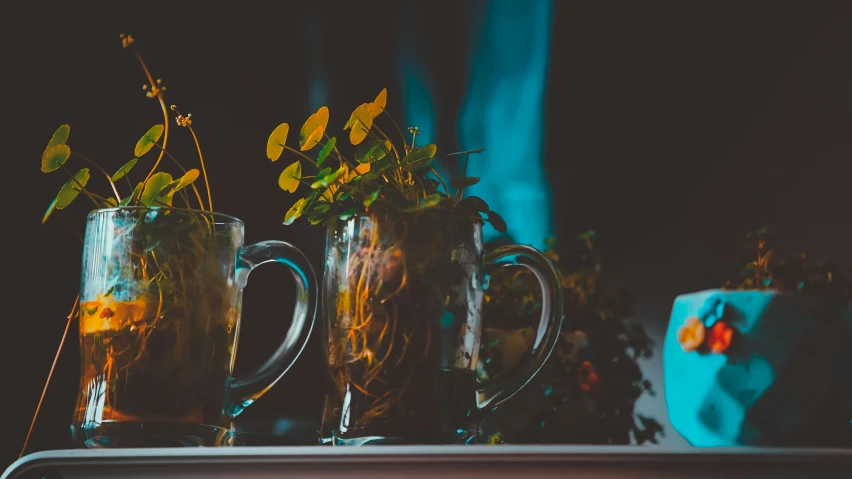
[478,231,663,444]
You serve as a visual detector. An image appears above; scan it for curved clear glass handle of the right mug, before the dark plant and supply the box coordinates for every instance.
[476,245,563,409]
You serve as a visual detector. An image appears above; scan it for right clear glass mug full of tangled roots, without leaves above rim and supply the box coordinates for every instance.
[320,212,563,445]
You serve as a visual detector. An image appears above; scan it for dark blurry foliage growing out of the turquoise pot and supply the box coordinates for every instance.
[723,228,852,305]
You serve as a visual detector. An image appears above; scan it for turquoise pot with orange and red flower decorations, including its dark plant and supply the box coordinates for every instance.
[663,228,852,447]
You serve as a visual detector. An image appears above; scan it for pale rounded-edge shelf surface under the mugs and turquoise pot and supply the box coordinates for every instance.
[0,445,852,479]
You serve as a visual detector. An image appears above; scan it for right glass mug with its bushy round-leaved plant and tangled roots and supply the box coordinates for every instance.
[266,90,562,445]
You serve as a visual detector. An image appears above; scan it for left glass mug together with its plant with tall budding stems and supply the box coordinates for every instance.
[27,35,316,454]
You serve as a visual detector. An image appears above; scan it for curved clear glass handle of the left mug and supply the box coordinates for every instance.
[224,240,317,418]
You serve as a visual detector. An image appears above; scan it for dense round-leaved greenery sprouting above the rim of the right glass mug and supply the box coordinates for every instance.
[266,89,506,232]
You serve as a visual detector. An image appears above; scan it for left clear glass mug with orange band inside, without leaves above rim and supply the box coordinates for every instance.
[71,207,317,447]
